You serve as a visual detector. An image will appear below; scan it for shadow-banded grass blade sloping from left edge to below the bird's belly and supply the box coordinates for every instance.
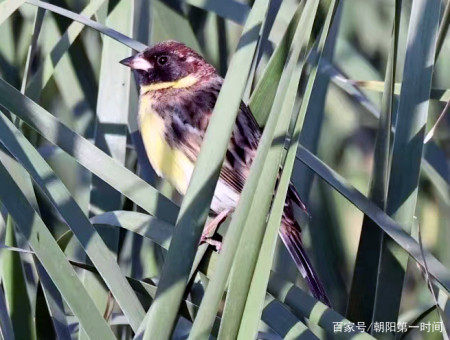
[0,79,178,223]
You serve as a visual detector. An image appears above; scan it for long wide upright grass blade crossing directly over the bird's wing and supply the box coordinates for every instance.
[138,0,268,340]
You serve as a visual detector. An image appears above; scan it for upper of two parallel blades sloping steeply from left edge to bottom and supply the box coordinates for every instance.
[0,115,144,329]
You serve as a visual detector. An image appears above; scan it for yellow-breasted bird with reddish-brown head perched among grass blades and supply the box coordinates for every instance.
[120,40,330,306]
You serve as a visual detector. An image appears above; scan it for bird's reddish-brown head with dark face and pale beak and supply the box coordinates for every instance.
[120,40,215,92]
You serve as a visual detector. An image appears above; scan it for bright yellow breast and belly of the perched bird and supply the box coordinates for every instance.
[139,96,194,194]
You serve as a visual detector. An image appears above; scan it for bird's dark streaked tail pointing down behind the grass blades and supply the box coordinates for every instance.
[280,221,331,306]
